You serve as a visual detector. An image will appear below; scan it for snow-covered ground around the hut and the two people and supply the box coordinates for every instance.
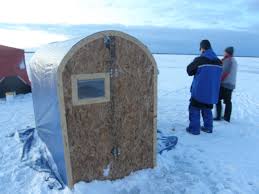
[0,55,259,194]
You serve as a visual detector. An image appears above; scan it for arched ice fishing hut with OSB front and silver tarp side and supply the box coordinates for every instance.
[30,31,157,187]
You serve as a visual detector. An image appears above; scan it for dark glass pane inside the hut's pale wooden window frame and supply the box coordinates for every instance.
[77,79,105,100]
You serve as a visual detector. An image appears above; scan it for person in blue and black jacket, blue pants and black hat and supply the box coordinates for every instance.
[186,40,222,135]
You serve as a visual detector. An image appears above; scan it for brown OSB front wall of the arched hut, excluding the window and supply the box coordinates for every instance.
[62,34,156,184]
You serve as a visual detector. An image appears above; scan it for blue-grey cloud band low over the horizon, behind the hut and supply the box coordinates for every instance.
[0,24,259,56]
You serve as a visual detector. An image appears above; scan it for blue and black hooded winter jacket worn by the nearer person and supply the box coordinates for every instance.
[187,49,222,104]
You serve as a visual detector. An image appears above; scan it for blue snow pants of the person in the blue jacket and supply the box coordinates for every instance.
[189,105,213,135]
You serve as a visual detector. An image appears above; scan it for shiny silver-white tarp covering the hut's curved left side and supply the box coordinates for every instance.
[30,38,82,184]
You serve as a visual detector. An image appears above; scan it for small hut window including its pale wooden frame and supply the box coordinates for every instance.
[72,73,110,105]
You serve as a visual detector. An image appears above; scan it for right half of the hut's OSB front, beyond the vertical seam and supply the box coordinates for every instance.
[105,37,155,178]
